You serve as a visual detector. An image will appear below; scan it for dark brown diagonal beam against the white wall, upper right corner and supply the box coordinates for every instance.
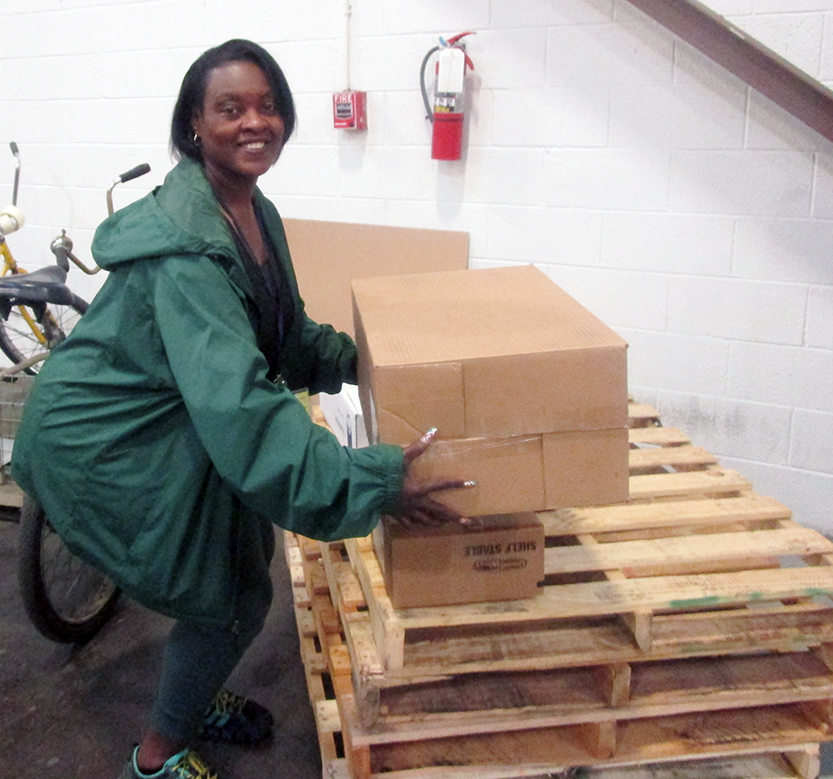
[629,0,833,141]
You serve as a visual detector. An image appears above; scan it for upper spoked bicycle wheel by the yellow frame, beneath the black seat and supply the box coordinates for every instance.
[0,295,87,374]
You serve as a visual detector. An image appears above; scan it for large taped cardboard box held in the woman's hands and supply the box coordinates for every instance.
[352,265,628,516]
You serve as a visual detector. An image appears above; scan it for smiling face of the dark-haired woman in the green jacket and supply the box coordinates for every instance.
[192,61,284,200]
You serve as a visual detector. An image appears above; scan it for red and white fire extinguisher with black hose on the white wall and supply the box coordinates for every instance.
[419,32,474,160]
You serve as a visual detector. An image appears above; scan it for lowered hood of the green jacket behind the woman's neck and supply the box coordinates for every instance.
[92,159,239,270]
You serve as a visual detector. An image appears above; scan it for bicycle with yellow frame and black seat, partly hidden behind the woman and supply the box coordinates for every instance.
[0,144,150,643]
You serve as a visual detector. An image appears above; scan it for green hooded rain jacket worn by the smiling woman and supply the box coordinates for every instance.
[12,160,403,626]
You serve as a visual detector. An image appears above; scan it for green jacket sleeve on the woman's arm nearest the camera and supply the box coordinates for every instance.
[152,257,403,540]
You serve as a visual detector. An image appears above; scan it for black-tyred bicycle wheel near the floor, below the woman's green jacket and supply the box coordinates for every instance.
[18,496,121,643]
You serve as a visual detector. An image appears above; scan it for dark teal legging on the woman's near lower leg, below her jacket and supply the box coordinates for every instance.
[150,619,263,744]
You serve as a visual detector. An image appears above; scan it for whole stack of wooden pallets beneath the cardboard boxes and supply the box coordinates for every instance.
[287,404,833,779]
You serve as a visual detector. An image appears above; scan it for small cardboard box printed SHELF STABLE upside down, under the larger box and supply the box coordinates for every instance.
[373,513,544,609]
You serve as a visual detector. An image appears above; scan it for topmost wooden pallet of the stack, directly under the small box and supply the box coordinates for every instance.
[336,406,833,679]
